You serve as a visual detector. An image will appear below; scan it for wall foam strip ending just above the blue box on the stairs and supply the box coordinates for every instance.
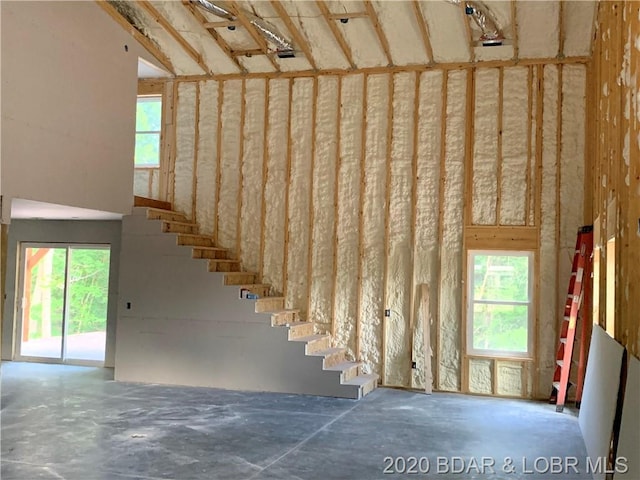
[240,79,266,272]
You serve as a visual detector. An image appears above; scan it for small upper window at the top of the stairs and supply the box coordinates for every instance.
[135,95,162,167]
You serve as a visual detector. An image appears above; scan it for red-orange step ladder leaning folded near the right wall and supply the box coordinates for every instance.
[549,225,593,412]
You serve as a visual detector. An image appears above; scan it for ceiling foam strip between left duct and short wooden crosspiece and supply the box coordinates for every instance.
[281,0,350,69]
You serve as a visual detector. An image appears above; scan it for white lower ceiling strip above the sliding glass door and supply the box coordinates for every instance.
[11,198,122,220]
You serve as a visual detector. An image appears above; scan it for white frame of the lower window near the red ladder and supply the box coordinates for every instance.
[465,249,536,360]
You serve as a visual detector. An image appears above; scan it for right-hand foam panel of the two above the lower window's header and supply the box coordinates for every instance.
[500,67,529,225]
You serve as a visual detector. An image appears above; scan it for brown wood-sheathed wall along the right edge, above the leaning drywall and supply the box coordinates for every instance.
[585,1,640,357]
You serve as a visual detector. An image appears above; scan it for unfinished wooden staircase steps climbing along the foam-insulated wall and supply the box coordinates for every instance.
[116,200,378,399]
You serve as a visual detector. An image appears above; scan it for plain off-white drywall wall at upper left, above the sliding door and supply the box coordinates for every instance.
[0,2,139,221]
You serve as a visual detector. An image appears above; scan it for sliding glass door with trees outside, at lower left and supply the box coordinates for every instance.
[17,244,110,364]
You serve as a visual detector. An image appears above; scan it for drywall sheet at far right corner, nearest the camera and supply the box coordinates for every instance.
[615,355,640,480]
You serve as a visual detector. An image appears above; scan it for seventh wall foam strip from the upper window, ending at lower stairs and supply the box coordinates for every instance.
[308,77,339,333]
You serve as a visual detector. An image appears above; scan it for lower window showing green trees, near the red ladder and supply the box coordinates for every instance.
[467,250,533,357]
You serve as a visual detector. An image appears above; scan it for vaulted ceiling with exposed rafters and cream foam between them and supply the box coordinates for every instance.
[98,0,597,76]
